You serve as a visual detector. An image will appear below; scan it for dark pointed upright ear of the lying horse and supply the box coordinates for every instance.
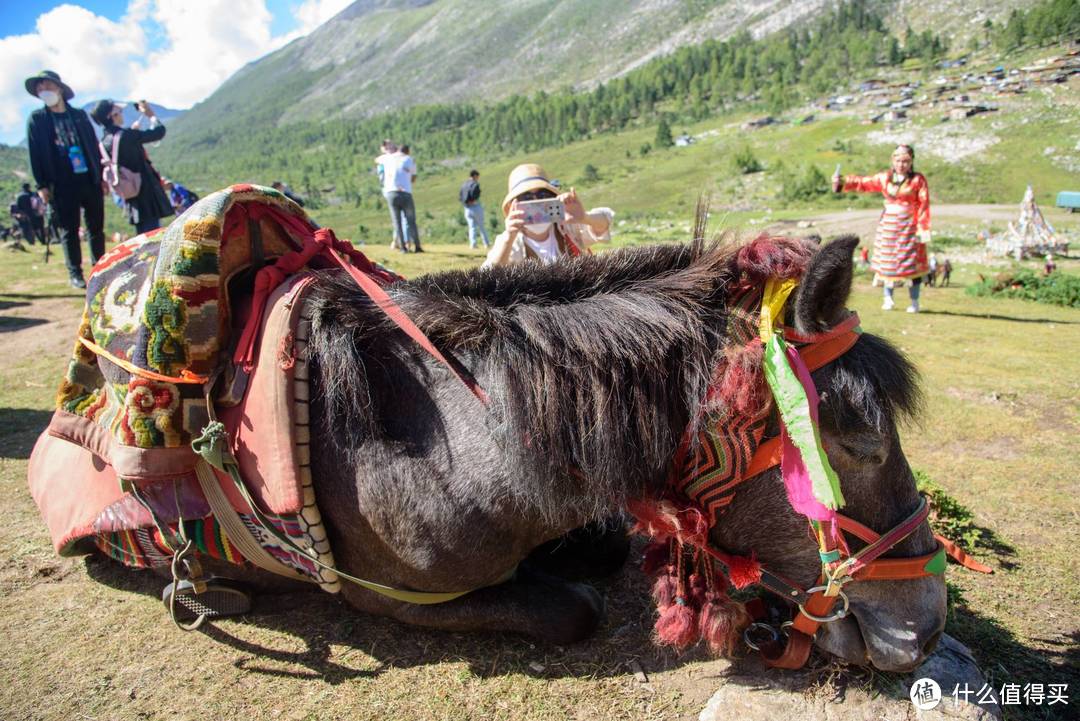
[795,235,859,334]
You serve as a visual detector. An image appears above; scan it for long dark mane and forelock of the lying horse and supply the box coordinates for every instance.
[310,234,916,524]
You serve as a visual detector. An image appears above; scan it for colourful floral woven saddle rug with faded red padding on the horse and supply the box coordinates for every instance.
[29,185,397,591]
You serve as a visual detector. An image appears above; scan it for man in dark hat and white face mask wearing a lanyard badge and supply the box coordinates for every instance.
[25,70,105,288]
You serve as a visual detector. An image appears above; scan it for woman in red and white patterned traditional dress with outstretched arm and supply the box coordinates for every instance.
[833,145,930,313]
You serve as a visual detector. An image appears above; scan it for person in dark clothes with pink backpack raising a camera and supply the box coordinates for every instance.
[90,99,173,233]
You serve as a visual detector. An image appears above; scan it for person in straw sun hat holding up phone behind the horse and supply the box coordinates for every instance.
[483,163,615,268]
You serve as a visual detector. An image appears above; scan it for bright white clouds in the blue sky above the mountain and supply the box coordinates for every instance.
[0,0,332,144]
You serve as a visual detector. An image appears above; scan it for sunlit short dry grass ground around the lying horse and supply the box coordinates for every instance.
[0,205,1080,721]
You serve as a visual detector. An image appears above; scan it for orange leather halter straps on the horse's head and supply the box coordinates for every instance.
[704,314,948,669]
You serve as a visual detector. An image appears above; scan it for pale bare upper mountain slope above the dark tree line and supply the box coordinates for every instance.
[174,0,1030,146]
